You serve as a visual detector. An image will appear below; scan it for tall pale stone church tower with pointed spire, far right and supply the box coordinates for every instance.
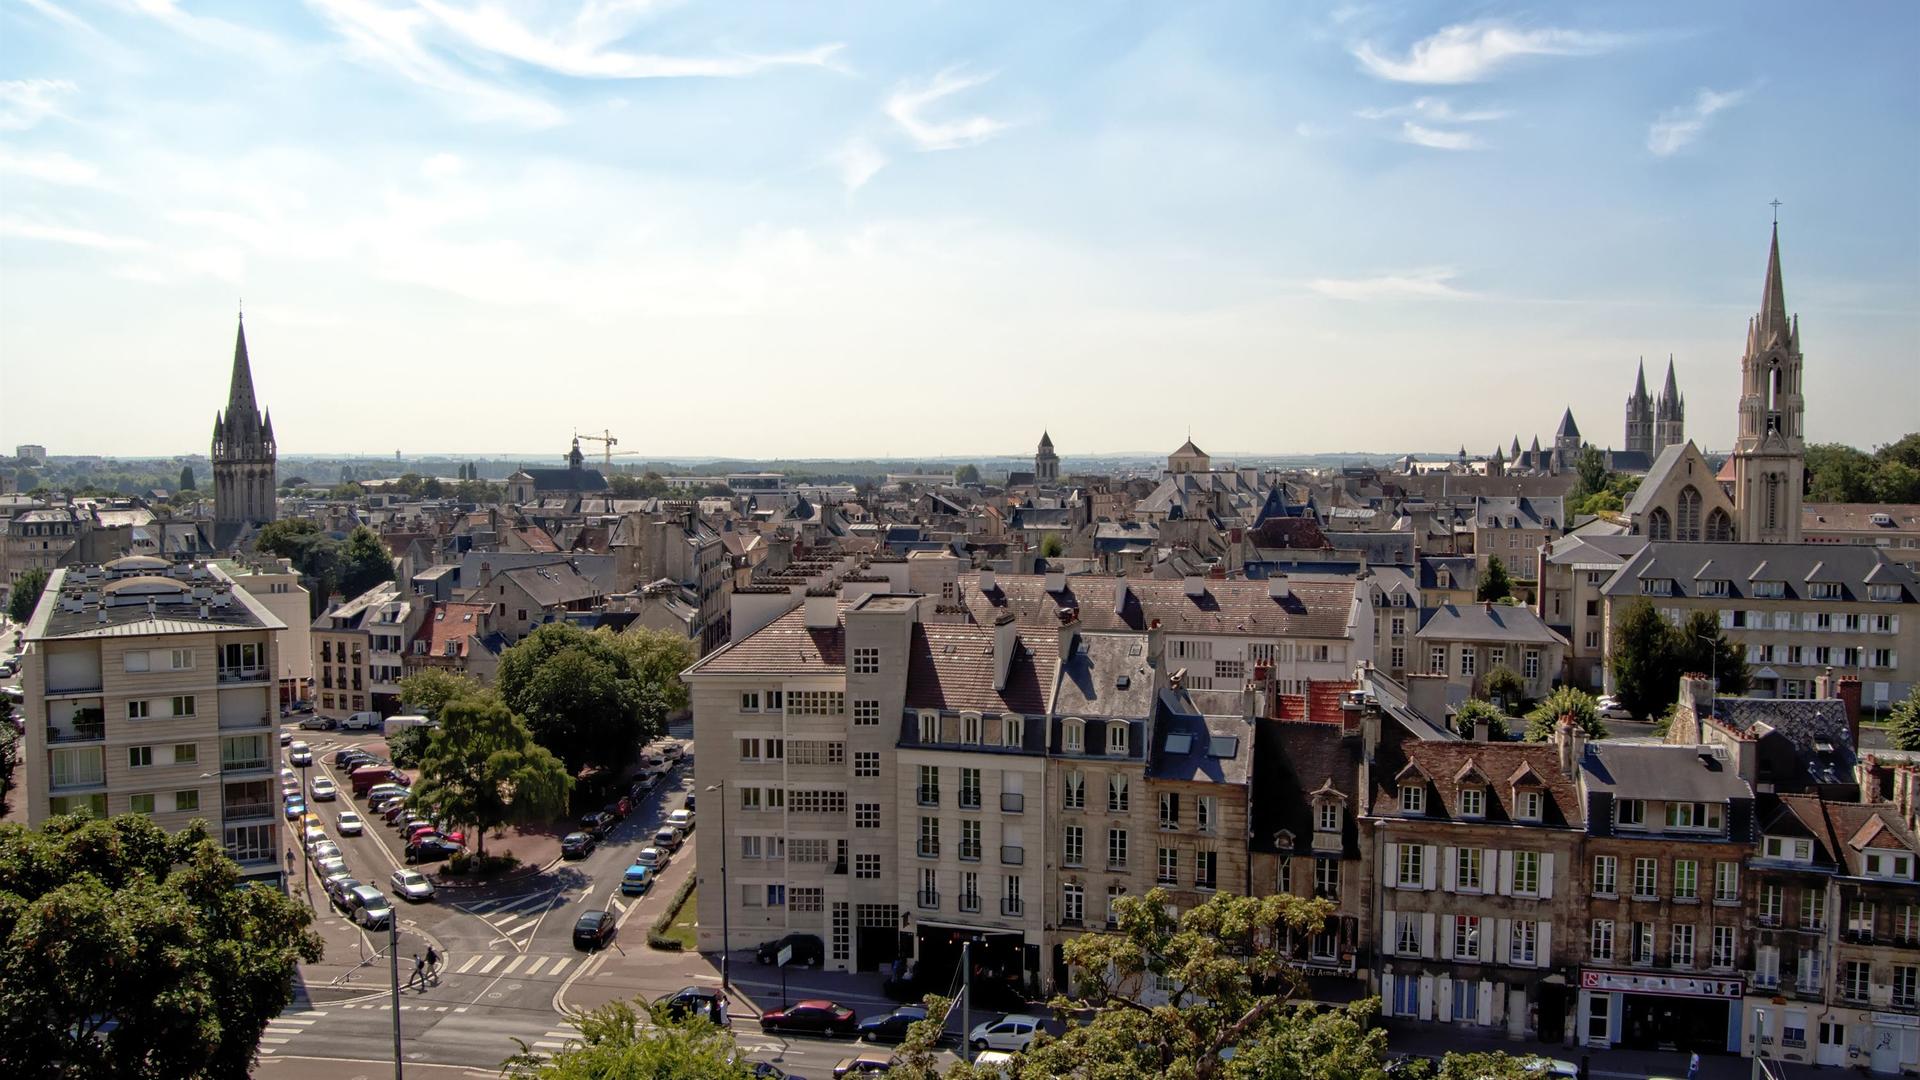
[1734,221,1807,544]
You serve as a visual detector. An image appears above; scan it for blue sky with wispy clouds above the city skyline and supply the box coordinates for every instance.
[0,0,1920,459]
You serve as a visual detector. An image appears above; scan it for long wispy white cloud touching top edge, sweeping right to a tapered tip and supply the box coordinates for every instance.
[420,0,841,79]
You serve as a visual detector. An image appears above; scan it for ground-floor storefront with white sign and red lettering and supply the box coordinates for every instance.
[1578,969,1745,1053]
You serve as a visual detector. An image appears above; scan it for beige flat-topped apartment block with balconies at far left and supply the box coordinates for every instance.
[21,555,284,884]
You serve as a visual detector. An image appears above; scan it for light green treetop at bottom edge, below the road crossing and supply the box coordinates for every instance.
[501,1001,753,1080]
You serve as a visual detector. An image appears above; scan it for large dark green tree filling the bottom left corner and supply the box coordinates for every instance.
[0,815,321,1080]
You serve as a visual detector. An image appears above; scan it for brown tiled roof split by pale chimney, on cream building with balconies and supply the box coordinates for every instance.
[902,623,1060,715]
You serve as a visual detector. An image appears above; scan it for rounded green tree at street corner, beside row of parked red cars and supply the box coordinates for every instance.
[411,696,574,855]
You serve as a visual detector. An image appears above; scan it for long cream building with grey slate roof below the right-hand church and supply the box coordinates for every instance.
[1601,542,1920,709]
